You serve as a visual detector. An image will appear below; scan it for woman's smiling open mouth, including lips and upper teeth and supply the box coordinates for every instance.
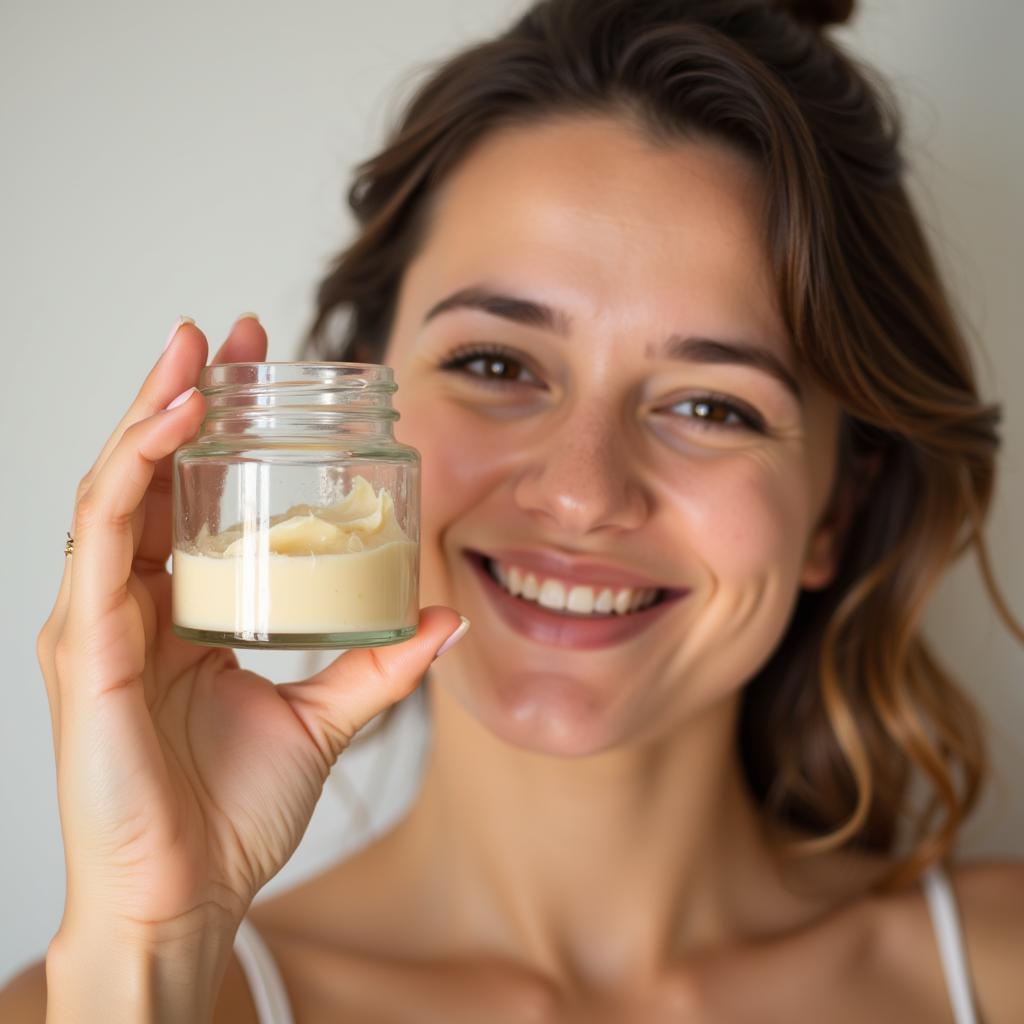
[466,551,688,649]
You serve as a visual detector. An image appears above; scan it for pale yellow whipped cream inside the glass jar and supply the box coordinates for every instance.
[172,476,419,634]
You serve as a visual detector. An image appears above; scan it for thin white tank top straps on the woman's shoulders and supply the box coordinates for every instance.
[234,866,978,1024]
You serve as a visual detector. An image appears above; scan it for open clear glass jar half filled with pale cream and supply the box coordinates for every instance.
[172,362,420,649]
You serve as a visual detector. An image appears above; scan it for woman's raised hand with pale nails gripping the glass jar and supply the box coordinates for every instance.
[37,317,460,1019]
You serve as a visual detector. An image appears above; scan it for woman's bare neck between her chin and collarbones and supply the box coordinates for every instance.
[391,680,810,986]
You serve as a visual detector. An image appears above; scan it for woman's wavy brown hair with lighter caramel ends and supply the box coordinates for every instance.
[296,0,1019,885]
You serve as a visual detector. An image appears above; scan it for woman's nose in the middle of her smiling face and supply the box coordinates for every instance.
[515,416,649,535]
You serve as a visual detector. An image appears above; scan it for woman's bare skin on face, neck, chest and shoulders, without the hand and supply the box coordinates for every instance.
[0,119,1024,1024]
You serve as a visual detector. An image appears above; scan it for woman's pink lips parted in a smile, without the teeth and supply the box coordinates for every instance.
[465,551,689,650]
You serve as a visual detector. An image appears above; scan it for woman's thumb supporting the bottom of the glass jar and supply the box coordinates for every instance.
[278,605,469,766]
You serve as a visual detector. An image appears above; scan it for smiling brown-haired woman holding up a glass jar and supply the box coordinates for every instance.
[0,0,1024,1024]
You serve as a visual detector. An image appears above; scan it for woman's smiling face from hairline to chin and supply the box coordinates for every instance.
[387,118,839,755]
